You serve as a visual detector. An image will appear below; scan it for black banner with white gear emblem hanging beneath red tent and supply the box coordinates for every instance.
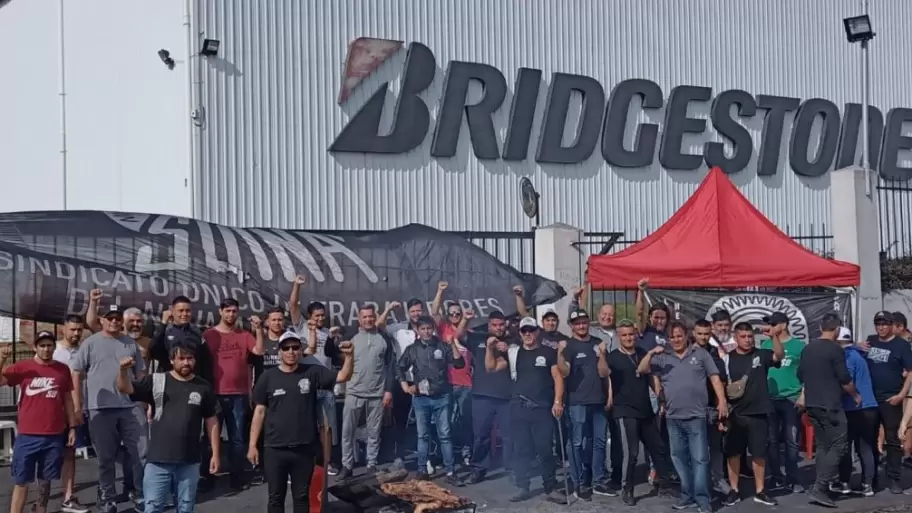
[648,290,851,341]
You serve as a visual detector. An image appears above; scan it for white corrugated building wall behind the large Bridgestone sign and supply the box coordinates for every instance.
[0,0,912,268]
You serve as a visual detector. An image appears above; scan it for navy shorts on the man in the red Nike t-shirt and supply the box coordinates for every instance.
[10,434,66,486]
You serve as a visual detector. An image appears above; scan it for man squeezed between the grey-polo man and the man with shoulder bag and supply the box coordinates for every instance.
[693,319,731,495]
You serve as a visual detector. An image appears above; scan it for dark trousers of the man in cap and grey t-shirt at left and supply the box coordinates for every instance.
[89,407,149,508]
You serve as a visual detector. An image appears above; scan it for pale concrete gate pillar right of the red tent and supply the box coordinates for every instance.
[830,167,883,330]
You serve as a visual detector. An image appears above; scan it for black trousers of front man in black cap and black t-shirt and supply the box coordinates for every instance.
[263,444,320,513]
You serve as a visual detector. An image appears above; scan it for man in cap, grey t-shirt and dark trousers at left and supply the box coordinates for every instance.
[69,305,148,513]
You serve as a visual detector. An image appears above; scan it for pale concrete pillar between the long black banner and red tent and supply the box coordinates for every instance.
[535,223,586,332]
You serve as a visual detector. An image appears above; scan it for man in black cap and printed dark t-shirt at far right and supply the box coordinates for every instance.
[865,312,912,493]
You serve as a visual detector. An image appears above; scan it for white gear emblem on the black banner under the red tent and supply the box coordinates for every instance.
[706,294,810,342]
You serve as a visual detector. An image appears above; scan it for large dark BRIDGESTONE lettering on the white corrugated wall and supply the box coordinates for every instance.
[329,43,912,180]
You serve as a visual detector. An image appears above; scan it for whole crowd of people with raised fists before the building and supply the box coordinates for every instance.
[0,277,912,513]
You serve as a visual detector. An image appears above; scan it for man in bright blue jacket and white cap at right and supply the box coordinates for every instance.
[830,327,880,497]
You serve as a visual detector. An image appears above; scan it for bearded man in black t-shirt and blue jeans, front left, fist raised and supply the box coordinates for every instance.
[117,341,221,513]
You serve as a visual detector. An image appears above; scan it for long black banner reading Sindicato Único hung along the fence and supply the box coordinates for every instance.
[0,211,565,326]
